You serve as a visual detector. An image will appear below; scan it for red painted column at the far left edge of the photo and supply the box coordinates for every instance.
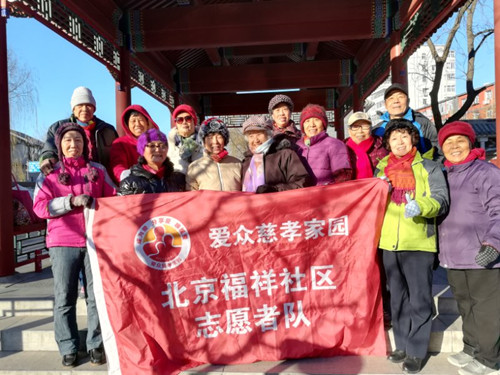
[0,0,15,276]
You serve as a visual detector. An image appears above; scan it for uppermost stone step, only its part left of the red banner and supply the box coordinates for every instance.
[0,297,87,317]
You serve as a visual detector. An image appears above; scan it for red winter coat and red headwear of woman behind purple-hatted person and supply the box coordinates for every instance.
[109,104,159,183]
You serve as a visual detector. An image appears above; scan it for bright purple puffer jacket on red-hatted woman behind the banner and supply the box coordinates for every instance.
[297,131,351,185]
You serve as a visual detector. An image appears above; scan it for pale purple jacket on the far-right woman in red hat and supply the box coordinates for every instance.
[439,159,500,269]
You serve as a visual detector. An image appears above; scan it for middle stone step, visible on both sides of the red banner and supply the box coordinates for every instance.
[0,315,463,353]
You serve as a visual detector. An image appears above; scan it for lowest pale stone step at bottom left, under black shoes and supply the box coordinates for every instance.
[0,351,108,375]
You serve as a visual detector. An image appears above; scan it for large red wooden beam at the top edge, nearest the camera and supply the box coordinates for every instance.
[129,0,389,51]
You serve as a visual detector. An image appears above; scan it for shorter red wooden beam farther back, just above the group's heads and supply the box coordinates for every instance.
[179,60,352,94]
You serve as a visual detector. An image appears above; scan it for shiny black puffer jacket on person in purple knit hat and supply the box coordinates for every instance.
[118,161,186,195]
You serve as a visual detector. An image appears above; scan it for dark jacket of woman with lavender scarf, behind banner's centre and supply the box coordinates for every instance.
[241,134,312,191]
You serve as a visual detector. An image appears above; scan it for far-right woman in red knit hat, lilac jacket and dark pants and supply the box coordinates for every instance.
[438,121,500,375]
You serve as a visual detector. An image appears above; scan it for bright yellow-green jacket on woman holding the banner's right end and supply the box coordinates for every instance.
[374,151,449,252]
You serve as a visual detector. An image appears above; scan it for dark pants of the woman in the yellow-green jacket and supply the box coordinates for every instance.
[383,250,435,358]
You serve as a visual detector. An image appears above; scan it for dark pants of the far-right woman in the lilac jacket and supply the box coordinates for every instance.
[448,268,500,368]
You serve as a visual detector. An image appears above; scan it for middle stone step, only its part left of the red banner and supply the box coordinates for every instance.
[0,316,87,352]
